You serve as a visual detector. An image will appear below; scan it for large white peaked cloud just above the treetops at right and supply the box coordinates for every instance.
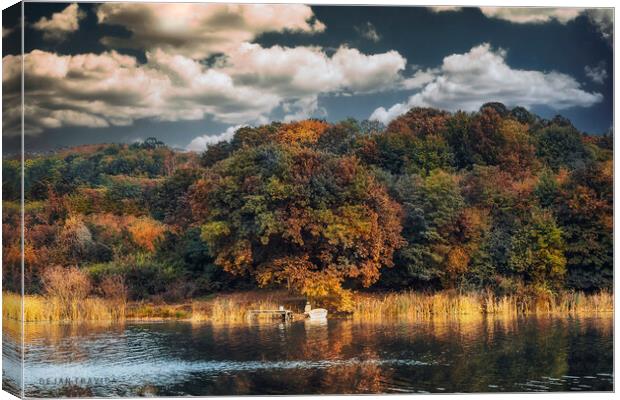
[370,43,603,123]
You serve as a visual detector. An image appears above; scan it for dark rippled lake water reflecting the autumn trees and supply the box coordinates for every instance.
[3,316,613,397]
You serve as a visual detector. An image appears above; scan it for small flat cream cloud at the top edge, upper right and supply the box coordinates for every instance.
[480,7,584,24]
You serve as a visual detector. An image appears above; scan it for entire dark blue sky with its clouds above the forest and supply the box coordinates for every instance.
[2,3,613,152]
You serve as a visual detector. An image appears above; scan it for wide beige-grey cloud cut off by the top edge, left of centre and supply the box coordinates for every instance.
[97,3,325,59]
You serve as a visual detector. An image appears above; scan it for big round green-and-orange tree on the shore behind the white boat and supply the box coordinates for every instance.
[191,144,402,310]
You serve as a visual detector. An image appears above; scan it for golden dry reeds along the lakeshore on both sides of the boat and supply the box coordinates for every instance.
[2,291,613,322]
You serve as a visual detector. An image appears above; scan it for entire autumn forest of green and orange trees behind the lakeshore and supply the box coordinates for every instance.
[2,103,613,313]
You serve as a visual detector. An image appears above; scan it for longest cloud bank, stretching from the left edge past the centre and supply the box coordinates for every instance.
[2,43,406,134]
